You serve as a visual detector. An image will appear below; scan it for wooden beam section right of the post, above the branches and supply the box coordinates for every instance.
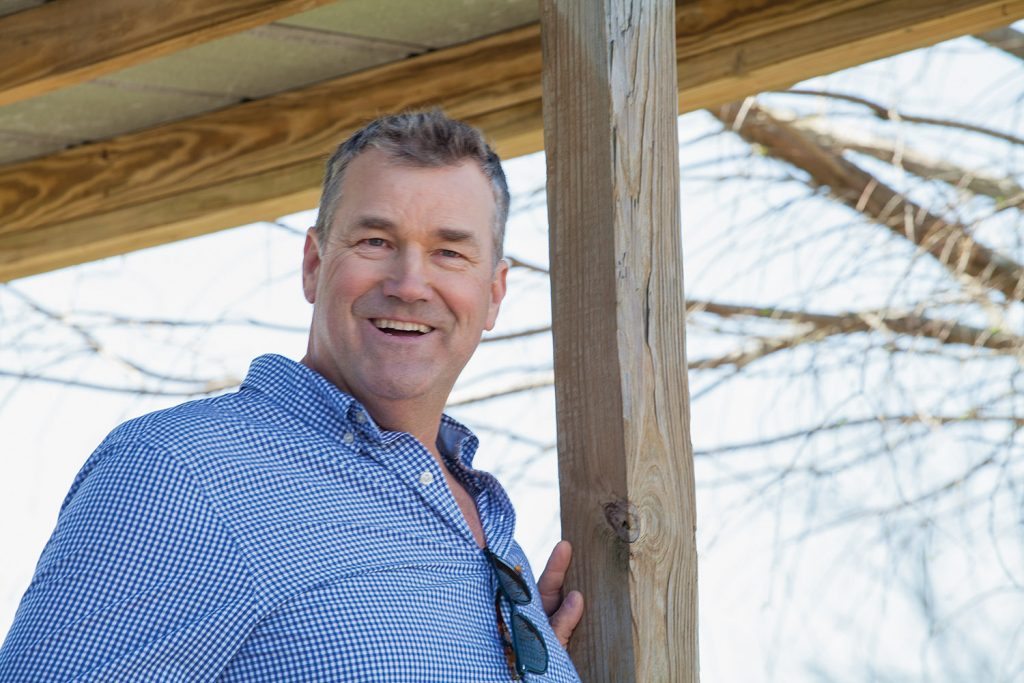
[676,0,1024,105]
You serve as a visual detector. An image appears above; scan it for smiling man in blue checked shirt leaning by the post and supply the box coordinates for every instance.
[0,112,583,683]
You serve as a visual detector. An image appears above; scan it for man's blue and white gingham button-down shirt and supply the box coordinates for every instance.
[0,355,579,683]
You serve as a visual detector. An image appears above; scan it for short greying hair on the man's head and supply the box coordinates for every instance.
[307,109,509,263]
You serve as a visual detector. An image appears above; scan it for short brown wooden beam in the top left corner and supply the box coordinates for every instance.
[0,0,333,106]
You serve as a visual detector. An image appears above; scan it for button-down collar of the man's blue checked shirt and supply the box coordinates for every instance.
[242,353,479,468]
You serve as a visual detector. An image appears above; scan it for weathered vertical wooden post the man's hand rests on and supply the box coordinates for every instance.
[541,0,698,683]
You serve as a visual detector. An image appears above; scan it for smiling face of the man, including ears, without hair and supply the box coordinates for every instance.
[302,150,508,410]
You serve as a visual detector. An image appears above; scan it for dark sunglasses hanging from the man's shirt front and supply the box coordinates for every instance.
[483,548,548,680]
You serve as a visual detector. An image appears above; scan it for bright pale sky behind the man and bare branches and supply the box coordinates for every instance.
[0,29,1024,681]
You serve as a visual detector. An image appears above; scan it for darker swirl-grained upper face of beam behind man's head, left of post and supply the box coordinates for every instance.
[0,27,541,234]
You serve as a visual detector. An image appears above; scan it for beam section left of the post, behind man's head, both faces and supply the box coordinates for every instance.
[0,26,541,281]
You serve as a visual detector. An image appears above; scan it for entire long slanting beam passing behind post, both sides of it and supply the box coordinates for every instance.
[0,0,1024,282]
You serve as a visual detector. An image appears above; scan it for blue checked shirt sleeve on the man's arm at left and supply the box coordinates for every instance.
[0,442,256,682]
